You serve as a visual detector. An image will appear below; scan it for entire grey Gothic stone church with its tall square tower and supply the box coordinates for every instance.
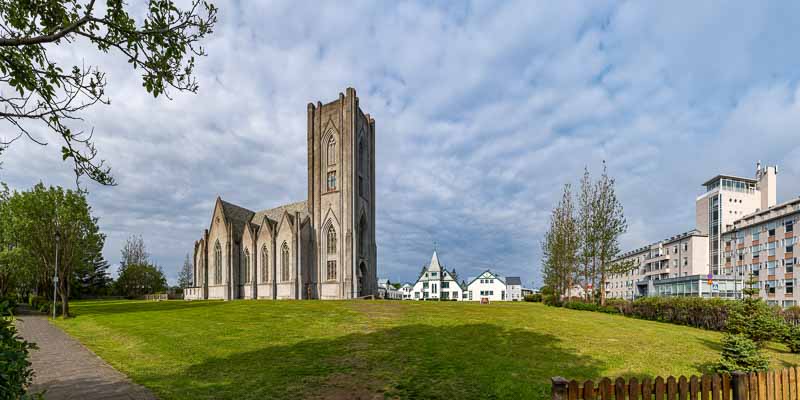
[184,88,377,300]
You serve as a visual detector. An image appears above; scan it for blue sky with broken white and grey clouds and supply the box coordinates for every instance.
[0,0,800,286]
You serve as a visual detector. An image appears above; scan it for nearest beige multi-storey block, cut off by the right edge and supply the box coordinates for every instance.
[722,199,800,307]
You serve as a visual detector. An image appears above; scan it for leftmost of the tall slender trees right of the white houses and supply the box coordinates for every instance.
[542,184,578,301]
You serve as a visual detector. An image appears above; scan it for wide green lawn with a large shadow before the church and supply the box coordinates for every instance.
[57,301,800,400]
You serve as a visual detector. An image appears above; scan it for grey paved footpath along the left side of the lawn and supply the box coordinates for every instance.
[17,311,156,400]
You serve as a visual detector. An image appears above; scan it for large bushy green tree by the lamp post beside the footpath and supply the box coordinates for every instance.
[0,183,105,316]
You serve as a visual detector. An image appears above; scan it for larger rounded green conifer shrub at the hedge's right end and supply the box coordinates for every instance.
[725,298,786,346]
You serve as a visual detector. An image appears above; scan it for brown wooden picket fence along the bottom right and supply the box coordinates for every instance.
[552,367,800,400]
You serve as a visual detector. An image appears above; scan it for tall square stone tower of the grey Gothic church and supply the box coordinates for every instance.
[308,88,378,299]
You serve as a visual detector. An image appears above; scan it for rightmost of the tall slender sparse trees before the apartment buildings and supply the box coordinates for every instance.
[592,161,631,305]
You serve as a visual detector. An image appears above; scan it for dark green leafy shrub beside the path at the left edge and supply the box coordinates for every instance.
[0,316,36,399]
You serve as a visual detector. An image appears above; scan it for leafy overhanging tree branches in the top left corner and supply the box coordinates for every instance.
[0,0,217,185]
